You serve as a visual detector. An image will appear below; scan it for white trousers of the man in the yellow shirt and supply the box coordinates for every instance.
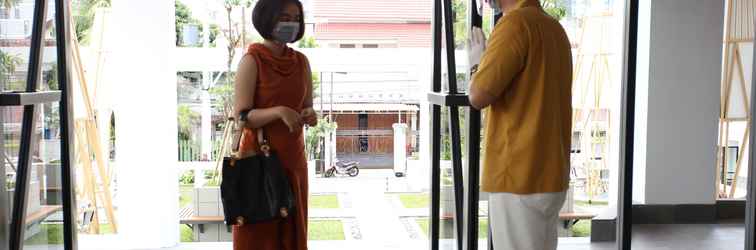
[488,192,566,250]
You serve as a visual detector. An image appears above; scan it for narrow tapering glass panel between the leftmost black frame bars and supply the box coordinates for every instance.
[22,0,64,249]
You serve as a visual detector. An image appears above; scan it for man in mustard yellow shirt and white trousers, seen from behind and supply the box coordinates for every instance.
[470,0,572,250]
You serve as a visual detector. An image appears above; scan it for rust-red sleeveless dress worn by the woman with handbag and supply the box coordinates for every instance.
[233,44,310,250]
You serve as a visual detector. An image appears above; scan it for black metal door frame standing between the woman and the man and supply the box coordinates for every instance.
[428,0,482,250]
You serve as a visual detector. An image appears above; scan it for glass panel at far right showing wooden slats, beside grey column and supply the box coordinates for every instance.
[717,0,756,200]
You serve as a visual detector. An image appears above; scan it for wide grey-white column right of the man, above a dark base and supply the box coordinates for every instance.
[633,0,724,204]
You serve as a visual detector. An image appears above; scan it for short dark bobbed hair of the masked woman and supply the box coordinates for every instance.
[252,0,305,41]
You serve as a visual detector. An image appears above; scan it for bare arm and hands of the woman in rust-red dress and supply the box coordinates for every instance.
[234,55,302,132]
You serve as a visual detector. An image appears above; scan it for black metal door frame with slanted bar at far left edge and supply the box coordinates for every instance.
[0,0,77,250]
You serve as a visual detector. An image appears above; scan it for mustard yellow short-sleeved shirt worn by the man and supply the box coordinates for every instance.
[471,0,572,194]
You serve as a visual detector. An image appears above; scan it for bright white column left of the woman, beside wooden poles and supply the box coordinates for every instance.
[110,0,179,249]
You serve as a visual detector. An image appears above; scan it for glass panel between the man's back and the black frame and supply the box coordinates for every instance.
[560,0,625,249]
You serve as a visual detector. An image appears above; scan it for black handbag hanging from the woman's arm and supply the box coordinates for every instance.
[220,119,295,226]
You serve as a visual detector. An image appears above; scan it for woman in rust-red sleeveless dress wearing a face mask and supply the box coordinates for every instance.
[233,0,317,250]
